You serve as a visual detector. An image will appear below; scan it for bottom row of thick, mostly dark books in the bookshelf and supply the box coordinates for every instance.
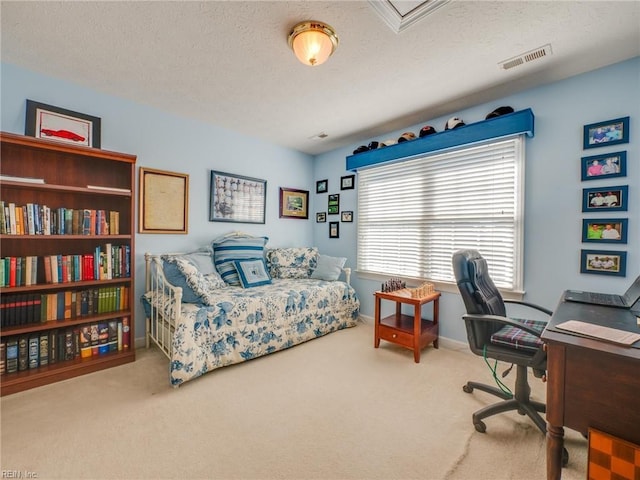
[0,317,131,375]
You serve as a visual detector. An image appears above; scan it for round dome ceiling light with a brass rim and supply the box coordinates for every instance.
[289,20,338,67]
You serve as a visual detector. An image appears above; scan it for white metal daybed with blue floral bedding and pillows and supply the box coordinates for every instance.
[142,234,360,386]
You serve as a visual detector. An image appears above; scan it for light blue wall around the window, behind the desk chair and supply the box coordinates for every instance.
[314,57,640,341]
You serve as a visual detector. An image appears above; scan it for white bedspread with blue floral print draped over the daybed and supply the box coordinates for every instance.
[146,278,360,385]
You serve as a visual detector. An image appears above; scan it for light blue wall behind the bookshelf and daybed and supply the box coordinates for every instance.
[0,63,315,339]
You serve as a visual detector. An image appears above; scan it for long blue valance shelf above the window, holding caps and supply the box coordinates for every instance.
[347,108,534,171]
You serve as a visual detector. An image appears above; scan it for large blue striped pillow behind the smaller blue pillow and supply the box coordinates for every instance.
[212,234,269,285]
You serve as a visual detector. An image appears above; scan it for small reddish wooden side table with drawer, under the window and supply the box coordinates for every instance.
[374,289,440,363]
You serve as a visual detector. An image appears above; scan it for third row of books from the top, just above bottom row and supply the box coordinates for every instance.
[0,285,129,328]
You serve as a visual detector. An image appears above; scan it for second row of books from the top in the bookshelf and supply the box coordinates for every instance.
[0,243,131,287]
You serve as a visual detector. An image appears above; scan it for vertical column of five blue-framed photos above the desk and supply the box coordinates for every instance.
[580,117,637,277]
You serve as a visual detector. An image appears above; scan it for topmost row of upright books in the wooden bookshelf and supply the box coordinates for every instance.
[0,200,120,235]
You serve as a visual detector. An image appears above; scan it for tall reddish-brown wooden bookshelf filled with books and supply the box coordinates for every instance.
[0,132,136,395]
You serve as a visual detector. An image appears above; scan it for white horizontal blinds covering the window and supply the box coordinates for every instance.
[357,135,524,291]
